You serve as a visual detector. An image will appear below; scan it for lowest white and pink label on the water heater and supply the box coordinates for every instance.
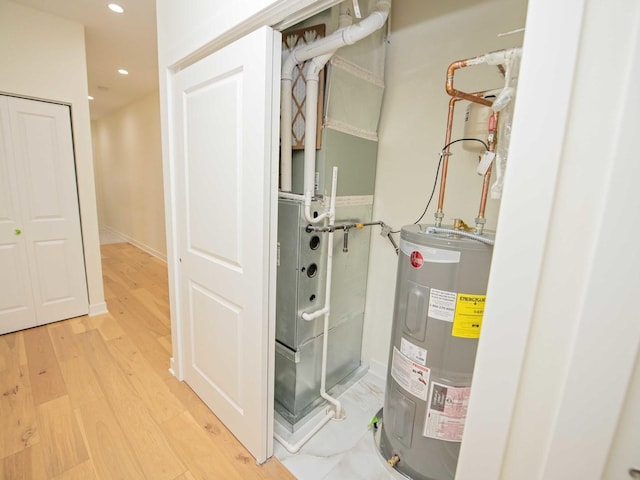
[422,382,471,442]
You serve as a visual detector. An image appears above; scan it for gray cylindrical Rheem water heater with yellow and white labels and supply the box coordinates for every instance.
[380,225,493,480]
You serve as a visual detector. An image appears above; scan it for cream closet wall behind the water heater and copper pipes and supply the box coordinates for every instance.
[363,0,526,376]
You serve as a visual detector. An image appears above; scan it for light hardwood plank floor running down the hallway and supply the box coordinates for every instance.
[0,244,294,480]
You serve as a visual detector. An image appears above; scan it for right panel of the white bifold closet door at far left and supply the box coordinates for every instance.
[9,98,89,325]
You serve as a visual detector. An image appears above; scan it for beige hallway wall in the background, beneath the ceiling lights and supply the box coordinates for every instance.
[92,91,167,259]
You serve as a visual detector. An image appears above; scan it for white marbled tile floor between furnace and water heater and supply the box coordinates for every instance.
[274,373,406,480]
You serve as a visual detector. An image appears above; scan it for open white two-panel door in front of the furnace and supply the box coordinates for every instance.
[172,27,280,463]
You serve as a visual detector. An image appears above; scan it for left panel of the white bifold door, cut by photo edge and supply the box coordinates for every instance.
[0,96,36,334]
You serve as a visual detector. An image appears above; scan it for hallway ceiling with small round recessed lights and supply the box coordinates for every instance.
[12,0,158,120]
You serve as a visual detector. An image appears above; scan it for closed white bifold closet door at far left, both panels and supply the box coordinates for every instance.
[0,96,89,333]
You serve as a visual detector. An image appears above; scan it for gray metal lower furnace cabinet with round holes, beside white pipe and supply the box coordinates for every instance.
[275,199,378,424]
